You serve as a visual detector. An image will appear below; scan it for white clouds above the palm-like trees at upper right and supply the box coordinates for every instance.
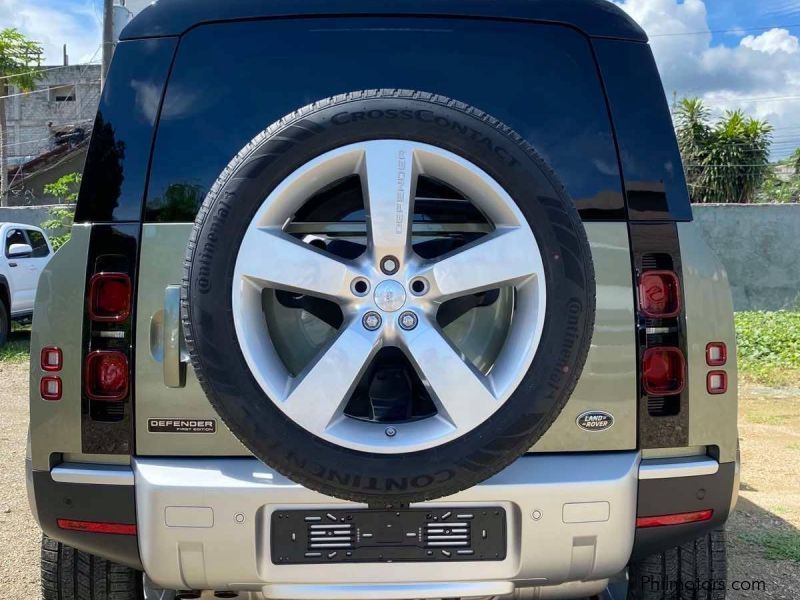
[617,0,800,158]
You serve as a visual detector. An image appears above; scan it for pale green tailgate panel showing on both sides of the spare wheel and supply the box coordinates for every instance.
[135,223,636,456]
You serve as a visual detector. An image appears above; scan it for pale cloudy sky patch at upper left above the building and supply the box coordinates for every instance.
[0,0,101,64]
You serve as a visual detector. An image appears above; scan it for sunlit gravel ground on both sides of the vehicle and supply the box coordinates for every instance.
[0,362,800,600]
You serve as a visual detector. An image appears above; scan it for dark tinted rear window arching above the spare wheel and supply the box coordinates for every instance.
[145,18,625,222]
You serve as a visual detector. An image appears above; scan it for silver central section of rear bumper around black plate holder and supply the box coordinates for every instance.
[134,452,639,598]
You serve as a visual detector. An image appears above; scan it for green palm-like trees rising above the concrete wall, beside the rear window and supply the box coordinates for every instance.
[676,98,772,203]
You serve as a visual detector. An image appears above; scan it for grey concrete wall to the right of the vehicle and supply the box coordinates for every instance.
[692,204,800,310]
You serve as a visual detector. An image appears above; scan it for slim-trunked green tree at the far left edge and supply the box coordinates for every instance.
[0,28,43,206]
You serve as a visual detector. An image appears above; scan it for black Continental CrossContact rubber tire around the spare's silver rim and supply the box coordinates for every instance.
[184,92,594,502]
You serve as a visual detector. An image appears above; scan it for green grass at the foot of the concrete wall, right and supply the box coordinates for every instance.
[735,311,800,387]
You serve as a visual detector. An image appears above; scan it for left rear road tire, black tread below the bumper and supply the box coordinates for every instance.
[41,535,144,600]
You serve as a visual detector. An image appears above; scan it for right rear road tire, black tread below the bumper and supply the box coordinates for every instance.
[628,529,728,600]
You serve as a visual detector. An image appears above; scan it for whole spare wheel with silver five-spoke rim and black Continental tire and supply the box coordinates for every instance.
[183,90,595,506]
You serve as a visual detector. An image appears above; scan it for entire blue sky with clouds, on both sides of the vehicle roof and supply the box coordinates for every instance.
[0,0,800,158]
